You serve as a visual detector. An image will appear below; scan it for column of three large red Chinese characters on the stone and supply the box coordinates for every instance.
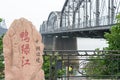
[20,30,30,67]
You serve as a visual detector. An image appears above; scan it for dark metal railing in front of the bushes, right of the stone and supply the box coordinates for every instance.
[44,50,120,80]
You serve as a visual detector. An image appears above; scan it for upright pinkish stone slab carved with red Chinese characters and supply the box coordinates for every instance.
[3,18,44,80]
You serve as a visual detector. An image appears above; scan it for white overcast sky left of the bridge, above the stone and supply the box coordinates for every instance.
[0,0,65,30]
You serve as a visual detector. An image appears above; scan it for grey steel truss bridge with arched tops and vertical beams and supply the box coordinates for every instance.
[40,0,120,37]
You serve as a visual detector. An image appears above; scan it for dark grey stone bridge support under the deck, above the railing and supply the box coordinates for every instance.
[43,36,77,50]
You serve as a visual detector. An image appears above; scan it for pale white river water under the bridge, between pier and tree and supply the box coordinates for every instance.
[77,37,108,50]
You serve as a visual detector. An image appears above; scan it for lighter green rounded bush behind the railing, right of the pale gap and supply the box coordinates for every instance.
[84,49,106,79]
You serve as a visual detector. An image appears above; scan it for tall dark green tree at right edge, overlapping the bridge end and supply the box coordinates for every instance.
[104,14,120,75]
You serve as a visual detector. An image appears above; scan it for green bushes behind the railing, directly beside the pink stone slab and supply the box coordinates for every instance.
[43,54,65,80]
